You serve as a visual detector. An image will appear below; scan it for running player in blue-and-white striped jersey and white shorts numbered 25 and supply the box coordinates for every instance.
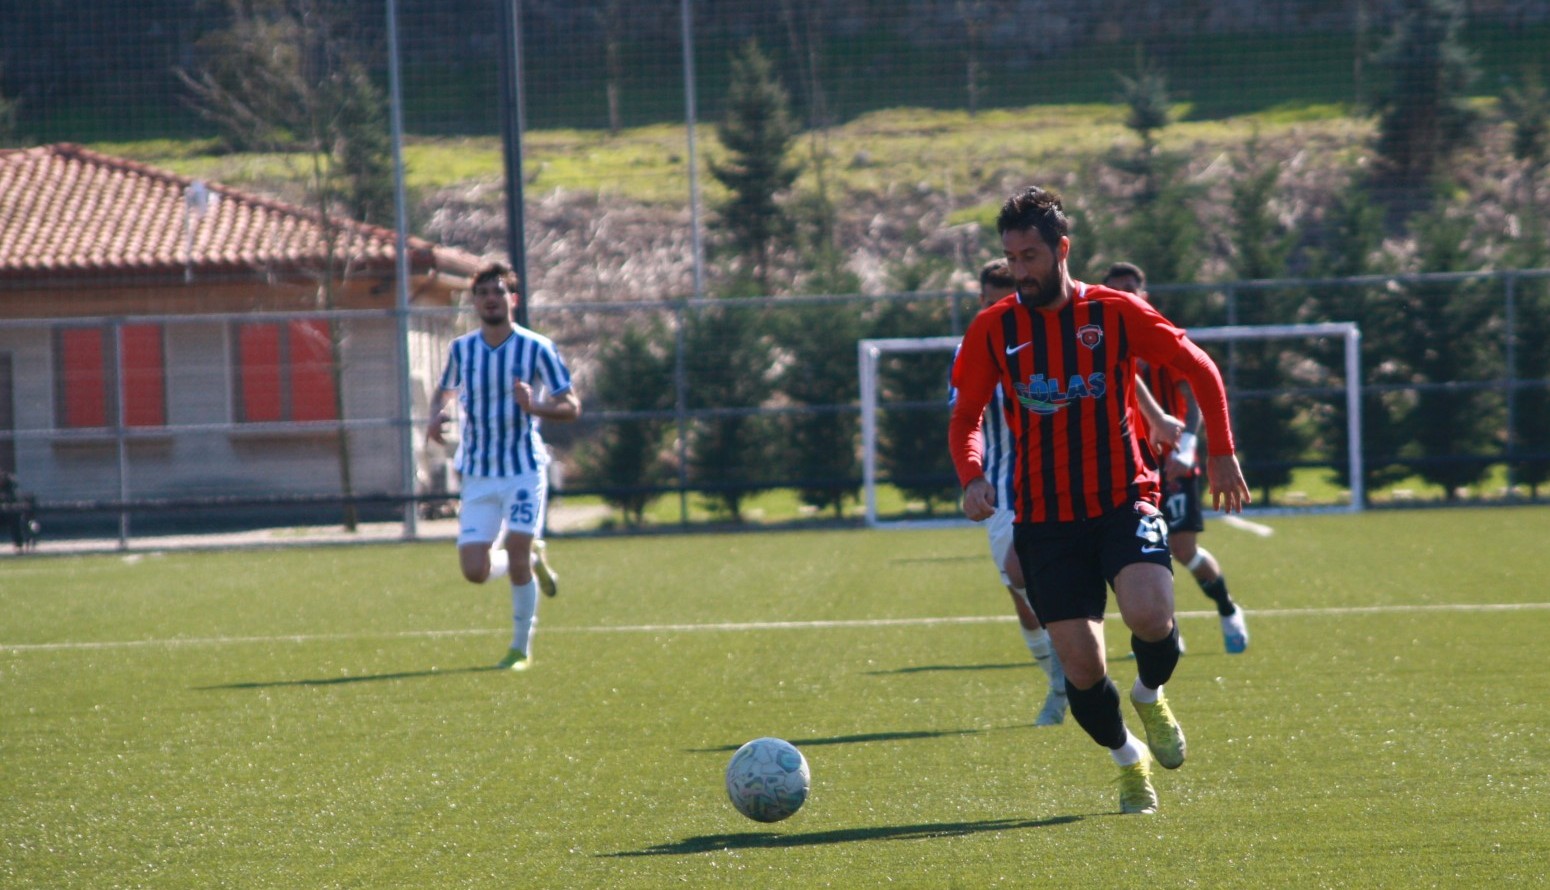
[426,264,581,670]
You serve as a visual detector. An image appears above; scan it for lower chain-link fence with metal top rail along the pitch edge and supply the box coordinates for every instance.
[0,273,1550,540]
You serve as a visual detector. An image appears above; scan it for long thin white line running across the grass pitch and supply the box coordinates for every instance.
[12,603,1550,653]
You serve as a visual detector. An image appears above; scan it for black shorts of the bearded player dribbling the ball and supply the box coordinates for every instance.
[1012,502,1173,623]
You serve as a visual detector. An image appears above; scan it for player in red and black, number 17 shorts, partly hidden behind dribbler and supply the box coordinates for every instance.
[1104,262,1249,654]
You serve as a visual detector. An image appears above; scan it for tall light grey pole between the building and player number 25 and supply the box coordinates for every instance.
[388,0,417,538]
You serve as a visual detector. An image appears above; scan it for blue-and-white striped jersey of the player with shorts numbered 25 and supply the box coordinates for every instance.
[440,327,570,478]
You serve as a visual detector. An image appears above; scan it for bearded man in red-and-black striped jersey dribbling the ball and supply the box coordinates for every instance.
[949,186,1249,812]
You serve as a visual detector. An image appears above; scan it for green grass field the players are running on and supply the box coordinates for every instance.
[0,507,1550,888]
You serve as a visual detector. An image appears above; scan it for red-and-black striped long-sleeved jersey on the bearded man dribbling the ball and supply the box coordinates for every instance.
[949,282,1232,523]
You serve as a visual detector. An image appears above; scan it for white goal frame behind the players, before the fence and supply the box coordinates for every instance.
[856,321,1367,529]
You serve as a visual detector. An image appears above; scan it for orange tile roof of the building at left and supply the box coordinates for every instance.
[0,143,479,281]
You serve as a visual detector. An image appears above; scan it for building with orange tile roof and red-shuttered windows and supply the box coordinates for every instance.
[0,144,482,533]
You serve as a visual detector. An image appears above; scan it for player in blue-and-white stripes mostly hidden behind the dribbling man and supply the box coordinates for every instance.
[947,259,1066,726]
